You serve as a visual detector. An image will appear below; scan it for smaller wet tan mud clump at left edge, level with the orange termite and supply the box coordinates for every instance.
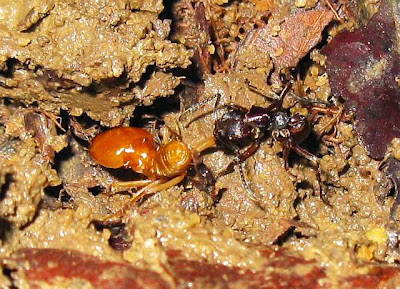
[0,102,62,227]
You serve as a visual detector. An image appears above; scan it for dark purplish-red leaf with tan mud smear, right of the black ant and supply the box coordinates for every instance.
[322,0,400,159]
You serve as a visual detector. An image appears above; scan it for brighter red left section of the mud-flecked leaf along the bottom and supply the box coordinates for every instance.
[7,249,171,289]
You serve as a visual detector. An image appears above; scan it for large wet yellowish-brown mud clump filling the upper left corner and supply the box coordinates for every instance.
[0,0,191,126]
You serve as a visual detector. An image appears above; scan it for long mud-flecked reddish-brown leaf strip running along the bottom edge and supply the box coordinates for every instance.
[0,247,400,289]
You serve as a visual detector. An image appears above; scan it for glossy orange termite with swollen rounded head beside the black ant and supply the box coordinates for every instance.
[89,127,214,202]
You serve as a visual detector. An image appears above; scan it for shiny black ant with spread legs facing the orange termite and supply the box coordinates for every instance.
[184,84,337,201]
